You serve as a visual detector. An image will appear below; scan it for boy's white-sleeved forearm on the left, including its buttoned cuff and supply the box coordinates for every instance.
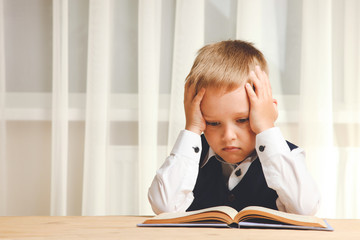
[148,130,201,214]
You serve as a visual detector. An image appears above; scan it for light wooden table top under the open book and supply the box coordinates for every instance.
[0,216,360,240]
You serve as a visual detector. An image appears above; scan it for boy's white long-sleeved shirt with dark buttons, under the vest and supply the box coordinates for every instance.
[148,127,320,215]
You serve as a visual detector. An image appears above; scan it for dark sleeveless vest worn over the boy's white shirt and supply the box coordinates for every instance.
[187,135,297,211]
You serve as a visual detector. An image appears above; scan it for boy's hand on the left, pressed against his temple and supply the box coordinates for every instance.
[184,82,206,135]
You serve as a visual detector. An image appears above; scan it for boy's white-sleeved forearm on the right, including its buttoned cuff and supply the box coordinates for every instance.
[256,128,320,215]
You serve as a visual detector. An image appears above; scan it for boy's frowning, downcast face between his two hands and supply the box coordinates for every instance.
[201,86,256,163]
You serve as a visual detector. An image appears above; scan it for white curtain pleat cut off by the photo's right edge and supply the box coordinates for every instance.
[339,0,360,218]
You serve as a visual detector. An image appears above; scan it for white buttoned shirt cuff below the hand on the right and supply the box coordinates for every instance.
[255,127,290,160]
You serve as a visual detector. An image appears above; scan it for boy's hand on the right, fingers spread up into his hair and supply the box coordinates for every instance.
[245,66,278,134]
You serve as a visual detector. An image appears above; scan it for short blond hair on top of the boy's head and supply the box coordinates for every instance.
[186,40,268,91]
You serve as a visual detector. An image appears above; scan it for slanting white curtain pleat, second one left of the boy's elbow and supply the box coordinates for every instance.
[82,0,111,215]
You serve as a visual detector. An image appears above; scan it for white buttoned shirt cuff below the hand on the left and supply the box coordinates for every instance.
[171,130,202,161]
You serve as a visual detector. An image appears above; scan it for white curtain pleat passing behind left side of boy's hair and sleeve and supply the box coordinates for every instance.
[168,0,205,152]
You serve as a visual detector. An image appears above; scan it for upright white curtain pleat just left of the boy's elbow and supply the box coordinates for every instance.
[138,0,162,214]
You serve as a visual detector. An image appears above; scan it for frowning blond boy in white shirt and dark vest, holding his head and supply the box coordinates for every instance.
[148,40,320,215]
